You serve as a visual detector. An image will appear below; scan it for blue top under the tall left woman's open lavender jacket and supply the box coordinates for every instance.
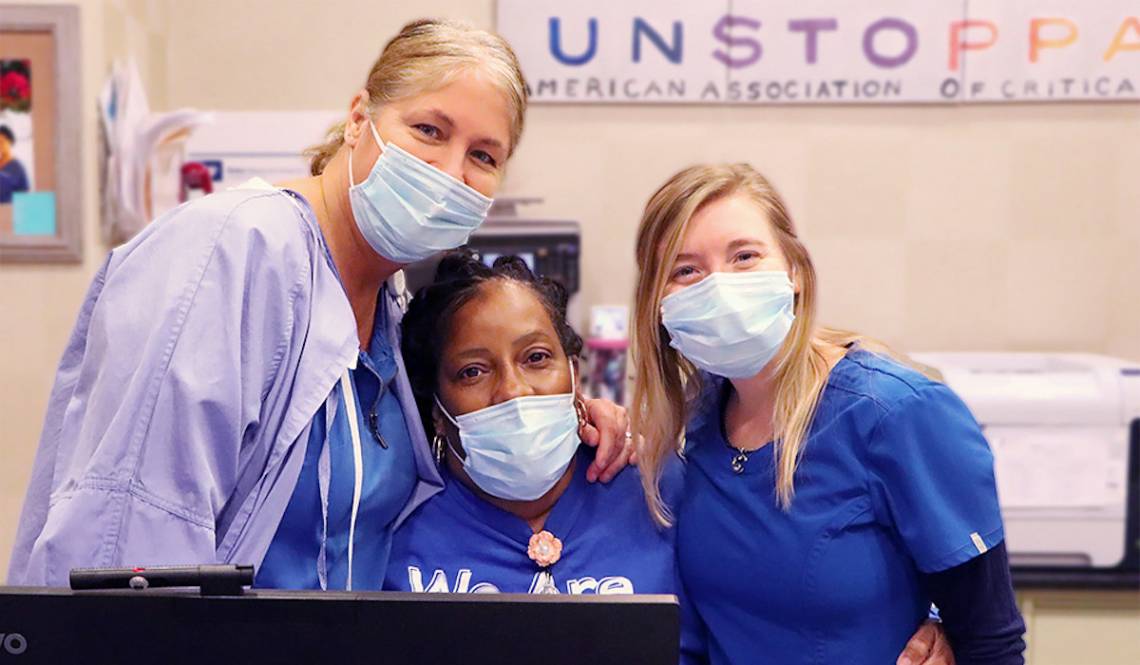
[257,307,416,590]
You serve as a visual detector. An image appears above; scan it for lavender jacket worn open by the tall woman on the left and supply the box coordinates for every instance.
[8,184,442,586]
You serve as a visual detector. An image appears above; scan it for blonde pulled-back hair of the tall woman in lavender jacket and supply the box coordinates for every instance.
[306,18,527,176]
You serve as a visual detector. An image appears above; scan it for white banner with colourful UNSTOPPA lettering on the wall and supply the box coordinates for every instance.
[497,0,1140,104]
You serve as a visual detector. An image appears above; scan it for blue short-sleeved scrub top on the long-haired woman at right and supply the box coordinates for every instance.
[677,350,1003,665]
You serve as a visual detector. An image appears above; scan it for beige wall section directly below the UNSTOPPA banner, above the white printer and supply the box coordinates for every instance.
[508,105,1140,359]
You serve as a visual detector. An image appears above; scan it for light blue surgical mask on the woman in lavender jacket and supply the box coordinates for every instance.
[349,121,492,263]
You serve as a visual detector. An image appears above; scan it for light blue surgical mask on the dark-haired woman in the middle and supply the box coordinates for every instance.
[435,364,581,501]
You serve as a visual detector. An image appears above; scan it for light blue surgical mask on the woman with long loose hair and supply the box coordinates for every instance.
[661,270,796,379]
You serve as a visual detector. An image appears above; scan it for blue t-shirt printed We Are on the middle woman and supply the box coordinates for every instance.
[384,446,700,660]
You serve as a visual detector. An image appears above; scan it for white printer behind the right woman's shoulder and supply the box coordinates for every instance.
[911,352,1140,568]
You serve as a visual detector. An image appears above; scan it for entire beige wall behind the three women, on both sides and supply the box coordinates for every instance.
[0,0,1140,665]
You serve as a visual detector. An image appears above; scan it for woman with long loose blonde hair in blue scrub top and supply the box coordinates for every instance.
[633,164,1025,665]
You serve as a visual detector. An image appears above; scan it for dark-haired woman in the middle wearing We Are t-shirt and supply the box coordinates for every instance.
[384,252,952,665]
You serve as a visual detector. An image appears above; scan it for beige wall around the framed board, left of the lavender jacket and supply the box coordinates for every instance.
[0,0,166,578]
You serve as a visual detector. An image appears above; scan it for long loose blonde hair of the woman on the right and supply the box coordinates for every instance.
[630,164,889,525]
